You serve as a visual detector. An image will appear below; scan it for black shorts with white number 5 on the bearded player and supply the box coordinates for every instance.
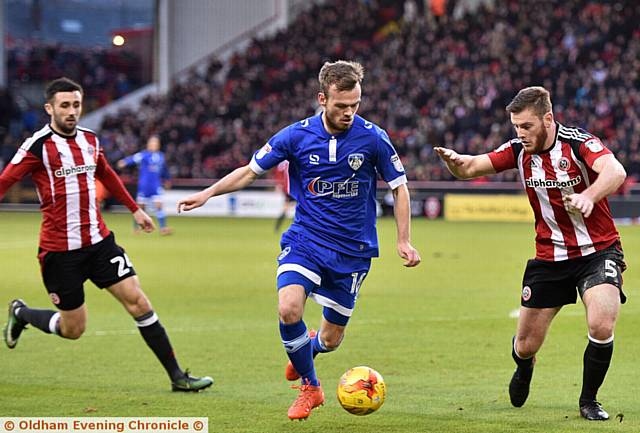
[520,242,627,308]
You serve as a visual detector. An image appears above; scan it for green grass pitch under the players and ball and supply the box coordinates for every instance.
[0,212,640,433]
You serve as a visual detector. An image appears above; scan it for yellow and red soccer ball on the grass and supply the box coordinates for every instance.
[338,366,387,415]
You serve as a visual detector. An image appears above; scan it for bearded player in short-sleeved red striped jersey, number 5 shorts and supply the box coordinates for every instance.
[435,87,626,420]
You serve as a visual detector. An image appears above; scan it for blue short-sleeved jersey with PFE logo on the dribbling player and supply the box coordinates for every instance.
[250,113,407,257]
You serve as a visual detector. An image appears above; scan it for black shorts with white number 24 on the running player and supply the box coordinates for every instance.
[38,233,136,311]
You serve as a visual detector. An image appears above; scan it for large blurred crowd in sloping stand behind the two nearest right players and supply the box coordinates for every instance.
[2,0,640,180]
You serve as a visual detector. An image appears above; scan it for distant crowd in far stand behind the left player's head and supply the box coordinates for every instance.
[0,37,145,169]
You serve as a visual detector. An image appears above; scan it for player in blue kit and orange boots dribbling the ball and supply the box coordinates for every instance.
[178,60,421,419]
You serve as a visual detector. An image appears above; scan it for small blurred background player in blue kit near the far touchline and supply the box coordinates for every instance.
[118,135,172,235]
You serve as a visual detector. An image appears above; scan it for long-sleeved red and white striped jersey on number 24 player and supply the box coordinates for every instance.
[0,125,138,251]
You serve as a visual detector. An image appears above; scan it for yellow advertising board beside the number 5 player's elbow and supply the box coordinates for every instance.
[444,194,533,222]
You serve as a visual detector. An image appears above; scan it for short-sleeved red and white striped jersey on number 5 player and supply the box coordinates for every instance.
[488,123,620,261]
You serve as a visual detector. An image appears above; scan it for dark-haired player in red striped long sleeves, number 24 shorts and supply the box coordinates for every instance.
[0,78,213,391]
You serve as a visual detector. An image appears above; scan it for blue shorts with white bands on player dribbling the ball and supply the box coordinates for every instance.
[277,231,371,326]
